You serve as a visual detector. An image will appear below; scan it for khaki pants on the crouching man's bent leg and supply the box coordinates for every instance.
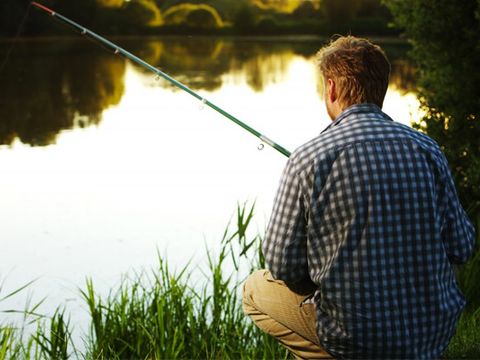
[243,270,332,359]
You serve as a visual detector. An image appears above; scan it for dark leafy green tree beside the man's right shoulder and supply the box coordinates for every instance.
[385,0,480,219]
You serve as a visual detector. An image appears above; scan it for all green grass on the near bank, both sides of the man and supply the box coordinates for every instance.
[0,204,480,360]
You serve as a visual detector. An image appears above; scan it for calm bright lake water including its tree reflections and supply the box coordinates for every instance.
[0,37,419,321]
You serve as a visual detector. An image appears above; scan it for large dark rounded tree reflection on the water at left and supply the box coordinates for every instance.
[0,41,125,146]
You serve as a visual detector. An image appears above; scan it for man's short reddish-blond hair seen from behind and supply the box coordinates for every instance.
[317,36,390,108]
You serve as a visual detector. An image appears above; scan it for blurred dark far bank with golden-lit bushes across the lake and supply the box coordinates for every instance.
[0,0,396,37]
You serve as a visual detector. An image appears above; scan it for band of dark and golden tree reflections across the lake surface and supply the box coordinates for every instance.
[0,37,415,146]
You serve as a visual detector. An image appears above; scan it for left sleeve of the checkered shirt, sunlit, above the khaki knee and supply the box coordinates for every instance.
[263,157,308,282]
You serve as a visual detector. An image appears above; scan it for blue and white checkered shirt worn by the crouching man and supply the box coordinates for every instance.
[263,104,474,359]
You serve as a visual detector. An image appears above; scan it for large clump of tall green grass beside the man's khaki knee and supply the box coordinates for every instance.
[82,202,287,359]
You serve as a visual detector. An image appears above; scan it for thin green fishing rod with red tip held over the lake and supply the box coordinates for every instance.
[31,1,290,157]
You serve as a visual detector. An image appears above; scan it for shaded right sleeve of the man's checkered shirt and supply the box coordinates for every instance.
[442,159,475,264]
